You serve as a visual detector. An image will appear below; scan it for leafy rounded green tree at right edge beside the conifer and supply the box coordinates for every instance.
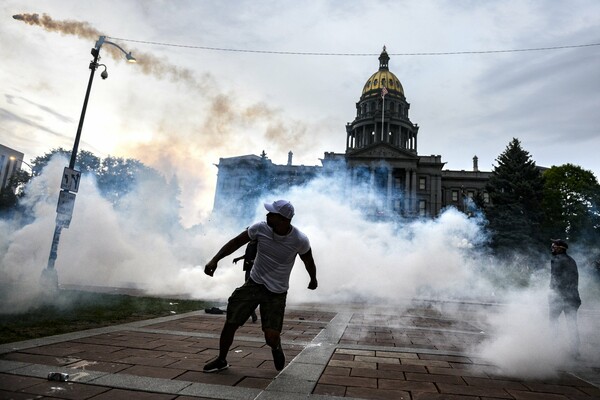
[543,164,600,244]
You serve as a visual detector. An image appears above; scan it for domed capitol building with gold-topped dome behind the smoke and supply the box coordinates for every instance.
[214,47,491,222]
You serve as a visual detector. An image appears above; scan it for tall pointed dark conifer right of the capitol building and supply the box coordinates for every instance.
[486,138,545,253]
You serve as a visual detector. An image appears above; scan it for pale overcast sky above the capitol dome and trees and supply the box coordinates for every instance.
[0,0,600,221]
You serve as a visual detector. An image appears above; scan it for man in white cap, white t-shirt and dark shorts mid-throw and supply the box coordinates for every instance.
[203,200,318,372]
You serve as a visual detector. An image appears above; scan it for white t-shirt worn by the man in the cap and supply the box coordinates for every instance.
[248,222,310,293]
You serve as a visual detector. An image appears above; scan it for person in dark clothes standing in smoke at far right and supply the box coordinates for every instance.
[548,239,581,356]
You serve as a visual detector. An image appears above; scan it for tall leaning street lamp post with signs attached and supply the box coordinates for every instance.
[42,36,136,290]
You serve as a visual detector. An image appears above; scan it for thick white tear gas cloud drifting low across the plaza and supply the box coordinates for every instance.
[0,157,600,377]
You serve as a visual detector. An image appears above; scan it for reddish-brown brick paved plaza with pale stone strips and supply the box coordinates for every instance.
[0,302,600,400]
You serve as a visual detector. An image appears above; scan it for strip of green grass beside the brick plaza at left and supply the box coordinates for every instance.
[0,290,210,344]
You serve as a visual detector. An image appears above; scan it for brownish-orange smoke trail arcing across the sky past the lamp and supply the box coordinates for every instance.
[13,10,316,222]
